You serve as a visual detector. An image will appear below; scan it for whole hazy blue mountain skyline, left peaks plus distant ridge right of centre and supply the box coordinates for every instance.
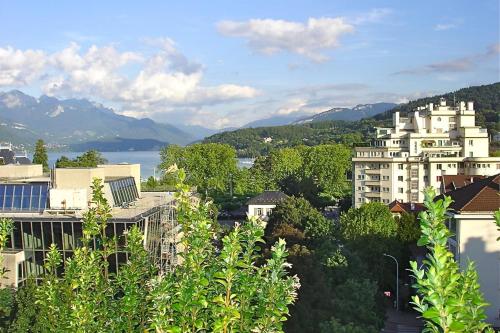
[0,90,396,151]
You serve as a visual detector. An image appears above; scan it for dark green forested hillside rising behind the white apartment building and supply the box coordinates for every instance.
[203,82,500,157]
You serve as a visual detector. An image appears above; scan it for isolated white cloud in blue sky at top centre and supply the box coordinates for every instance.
[217,17,354,62]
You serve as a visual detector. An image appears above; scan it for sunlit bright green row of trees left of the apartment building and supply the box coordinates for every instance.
[160,143,351,209]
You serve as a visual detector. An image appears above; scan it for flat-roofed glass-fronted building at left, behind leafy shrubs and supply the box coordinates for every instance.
[0,164,177,286]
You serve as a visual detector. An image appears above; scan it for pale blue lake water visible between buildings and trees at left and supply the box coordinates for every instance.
[48,151,253,179]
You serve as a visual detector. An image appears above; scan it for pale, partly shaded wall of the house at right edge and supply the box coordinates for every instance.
[454,213,500,326]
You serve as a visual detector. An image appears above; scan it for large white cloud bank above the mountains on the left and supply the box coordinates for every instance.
[0,38,259,126]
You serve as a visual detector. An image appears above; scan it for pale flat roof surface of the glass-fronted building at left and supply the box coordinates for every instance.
[0,192,174,220]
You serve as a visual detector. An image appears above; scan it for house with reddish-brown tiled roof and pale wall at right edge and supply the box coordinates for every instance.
[436,174,500,327]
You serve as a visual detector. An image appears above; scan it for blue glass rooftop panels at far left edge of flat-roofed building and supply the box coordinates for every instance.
[0,183,49,212]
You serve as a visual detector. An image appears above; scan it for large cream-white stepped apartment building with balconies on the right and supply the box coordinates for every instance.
[352,99,500,207]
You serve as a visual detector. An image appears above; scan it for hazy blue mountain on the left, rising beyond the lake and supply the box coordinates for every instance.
[0,90,196,145]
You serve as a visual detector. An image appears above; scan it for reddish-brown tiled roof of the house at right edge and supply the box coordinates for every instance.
[436,174,500,212]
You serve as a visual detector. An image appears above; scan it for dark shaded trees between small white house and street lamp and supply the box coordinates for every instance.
[266,197,383,333]
